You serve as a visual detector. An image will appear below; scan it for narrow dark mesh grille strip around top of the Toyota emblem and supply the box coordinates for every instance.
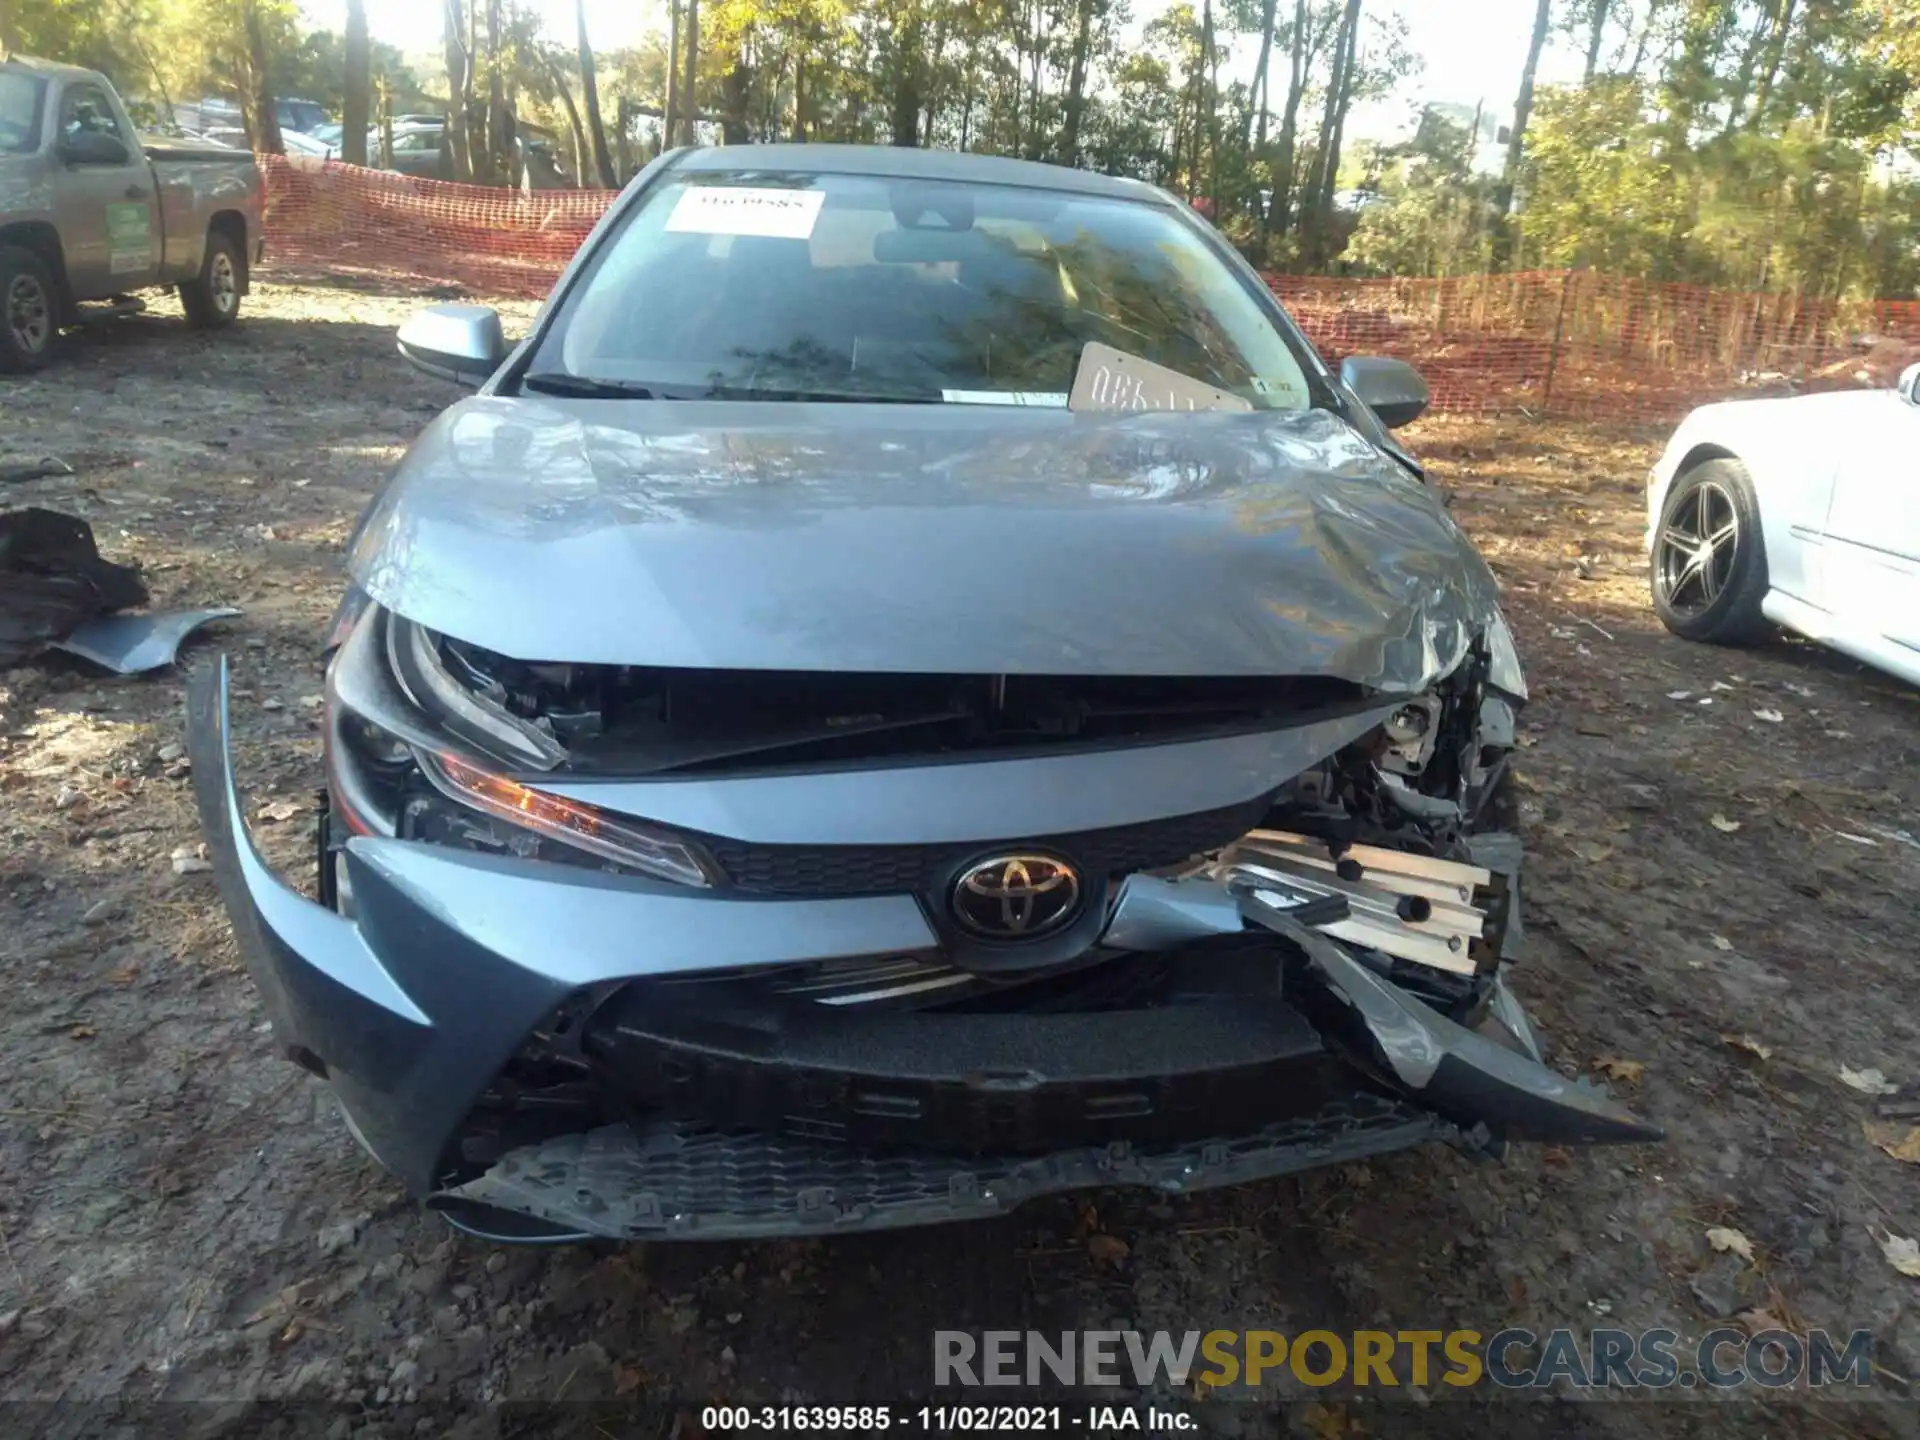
[701,797,1267,895]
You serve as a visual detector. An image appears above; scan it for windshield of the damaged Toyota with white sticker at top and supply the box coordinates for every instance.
[530,173,1311,411]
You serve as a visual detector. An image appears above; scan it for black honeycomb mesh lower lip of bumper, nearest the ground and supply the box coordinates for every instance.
[439,1094,1459,1240]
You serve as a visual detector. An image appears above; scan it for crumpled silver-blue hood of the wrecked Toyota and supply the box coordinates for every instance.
[351,397,1496,691]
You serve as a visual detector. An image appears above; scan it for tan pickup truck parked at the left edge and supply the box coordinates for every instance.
[0,58,265,372]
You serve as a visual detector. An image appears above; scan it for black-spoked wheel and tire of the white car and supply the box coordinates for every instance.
[1651,459,1772,645]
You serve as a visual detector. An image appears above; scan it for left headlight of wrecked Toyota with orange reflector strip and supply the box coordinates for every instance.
[326,607,712,887]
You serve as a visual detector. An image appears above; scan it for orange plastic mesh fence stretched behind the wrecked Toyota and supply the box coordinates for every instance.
[261,156,1920,420]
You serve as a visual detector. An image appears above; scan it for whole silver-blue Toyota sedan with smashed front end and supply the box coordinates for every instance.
[190,146,1657,1240]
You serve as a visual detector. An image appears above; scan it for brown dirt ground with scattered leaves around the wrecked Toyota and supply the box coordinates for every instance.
[0,284,1920,1438]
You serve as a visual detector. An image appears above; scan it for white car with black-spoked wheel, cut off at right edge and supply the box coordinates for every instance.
[1647,365,1920,685]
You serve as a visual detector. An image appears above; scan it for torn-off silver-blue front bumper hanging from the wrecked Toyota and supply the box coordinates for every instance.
[188,659,1657,1238]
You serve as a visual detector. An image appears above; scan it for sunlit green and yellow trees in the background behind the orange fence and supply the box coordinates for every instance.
[0,0,1920,298]
